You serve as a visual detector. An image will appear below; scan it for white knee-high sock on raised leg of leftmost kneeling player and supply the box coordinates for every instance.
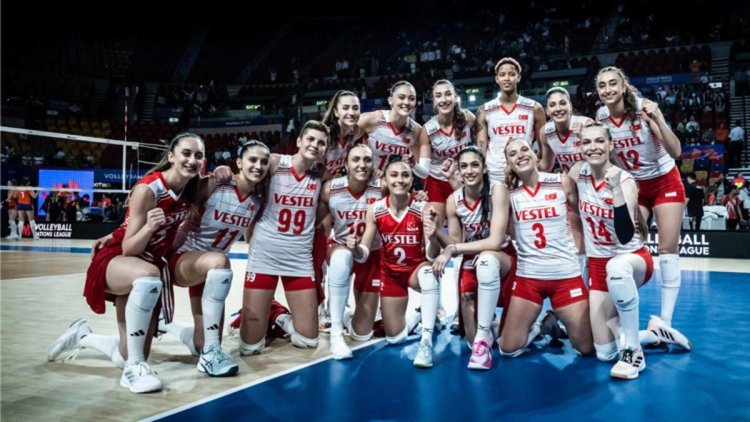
[125,277,162,363]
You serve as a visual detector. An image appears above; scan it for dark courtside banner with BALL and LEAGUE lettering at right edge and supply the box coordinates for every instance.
[646,231,750,259]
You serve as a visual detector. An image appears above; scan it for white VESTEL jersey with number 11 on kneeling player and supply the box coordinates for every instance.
[177,181,260,253]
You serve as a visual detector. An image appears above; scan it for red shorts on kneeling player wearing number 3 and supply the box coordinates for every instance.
[512,275,589,309]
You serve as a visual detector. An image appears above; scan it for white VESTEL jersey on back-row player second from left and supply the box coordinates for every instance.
[367,111,416,171]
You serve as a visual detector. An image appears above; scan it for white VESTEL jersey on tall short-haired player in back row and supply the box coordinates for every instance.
[482,95,536,182]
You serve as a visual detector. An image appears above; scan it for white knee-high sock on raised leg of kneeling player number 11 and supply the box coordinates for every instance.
[201,269,232,351]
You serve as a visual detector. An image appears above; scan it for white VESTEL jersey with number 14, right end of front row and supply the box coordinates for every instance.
[576,163,643,258]
